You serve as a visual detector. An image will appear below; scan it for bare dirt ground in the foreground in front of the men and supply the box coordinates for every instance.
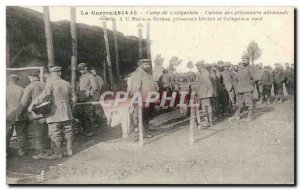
[7,102,294,184]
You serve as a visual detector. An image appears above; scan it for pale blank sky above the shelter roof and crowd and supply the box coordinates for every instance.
[27,7,294,72]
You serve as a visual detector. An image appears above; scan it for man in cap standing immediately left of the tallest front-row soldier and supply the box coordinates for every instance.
[221,62,235,109]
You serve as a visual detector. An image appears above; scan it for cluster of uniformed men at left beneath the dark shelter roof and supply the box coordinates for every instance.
[6,63,104,160]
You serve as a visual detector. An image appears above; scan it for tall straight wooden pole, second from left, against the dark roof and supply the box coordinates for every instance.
[71,7,77,90]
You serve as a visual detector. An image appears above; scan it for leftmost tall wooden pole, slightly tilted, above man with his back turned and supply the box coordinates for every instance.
[43,7,55,67]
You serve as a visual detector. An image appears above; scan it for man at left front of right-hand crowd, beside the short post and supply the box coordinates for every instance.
[196,64,214,127]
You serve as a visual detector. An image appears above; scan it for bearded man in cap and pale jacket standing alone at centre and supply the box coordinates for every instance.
[128,59,159,138]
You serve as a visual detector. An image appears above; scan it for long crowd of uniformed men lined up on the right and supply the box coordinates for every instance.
[158,56,295,126]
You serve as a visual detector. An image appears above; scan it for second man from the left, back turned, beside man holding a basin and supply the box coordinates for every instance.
[21,70,48,160]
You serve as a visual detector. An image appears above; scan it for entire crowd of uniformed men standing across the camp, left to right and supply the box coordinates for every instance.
[6,56,294,160]
